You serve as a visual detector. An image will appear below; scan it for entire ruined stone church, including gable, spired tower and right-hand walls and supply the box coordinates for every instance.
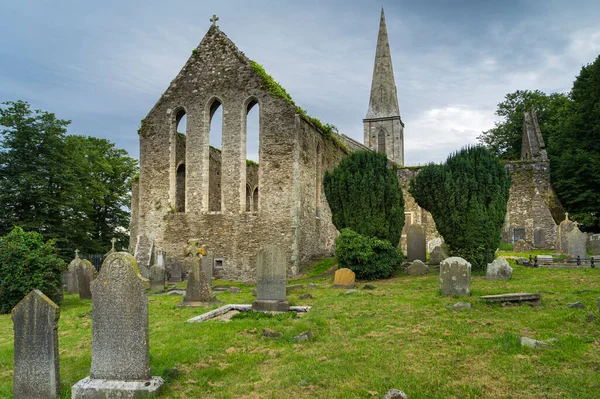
[129,10,562,280]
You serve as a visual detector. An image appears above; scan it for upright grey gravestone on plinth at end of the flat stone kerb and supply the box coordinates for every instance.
[252,246,290,312]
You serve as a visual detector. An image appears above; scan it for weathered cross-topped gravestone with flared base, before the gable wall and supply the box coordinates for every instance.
[177,239,217,307]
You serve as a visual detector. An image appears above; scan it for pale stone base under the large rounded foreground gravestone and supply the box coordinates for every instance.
[71,377,165,399]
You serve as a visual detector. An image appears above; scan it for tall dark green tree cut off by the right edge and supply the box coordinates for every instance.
[548,56,600,232]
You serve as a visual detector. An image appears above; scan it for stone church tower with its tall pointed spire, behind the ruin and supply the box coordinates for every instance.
[363,8,404,166]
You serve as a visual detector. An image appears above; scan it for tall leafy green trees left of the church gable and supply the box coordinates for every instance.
[0,101,137,259]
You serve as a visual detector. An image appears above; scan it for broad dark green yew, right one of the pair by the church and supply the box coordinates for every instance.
[409,146,510,270]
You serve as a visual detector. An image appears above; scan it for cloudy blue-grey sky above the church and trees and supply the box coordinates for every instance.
[0,0,600,165]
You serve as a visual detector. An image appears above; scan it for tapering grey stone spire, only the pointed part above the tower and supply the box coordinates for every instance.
[366,7,400,119]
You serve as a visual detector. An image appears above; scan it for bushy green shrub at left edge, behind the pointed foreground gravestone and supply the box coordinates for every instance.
[0,227,65,313]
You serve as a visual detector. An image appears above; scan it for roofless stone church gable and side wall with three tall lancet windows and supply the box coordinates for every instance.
[130,26,346,280]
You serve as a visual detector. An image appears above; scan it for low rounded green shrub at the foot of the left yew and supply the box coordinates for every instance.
[335,229,403,280]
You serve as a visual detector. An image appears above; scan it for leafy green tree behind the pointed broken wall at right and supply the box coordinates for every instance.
[477,90,570,160]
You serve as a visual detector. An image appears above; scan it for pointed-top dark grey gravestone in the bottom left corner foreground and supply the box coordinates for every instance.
[11,290,60,399]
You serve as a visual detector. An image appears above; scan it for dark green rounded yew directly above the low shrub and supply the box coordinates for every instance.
[323,151,404,246]
